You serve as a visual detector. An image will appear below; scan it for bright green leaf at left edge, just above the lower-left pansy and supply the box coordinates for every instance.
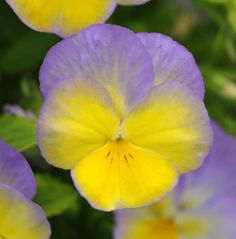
[0,114,36,151]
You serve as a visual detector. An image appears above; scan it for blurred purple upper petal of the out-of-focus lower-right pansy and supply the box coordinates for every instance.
[174,122,236,212]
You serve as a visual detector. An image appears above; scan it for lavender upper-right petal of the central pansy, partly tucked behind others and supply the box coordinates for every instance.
[138,33,205,99]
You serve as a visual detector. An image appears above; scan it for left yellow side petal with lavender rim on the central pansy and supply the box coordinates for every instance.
[37,78,120,169]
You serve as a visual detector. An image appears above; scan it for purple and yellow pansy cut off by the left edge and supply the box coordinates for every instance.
[0,141,50,239]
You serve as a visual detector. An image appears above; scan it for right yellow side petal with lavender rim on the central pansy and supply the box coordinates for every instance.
[123,83,212,173]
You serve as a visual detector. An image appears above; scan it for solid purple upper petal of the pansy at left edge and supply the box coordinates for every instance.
[0,141,36,199]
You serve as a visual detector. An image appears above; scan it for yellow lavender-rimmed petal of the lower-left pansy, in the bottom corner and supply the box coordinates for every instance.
[0,184,51,239]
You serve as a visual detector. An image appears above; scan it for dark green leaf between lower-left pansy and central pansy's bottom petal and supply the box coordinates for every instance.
[34,174,78,217]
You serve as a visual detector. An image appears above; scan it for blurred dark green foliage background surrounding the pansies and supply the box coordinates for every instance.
[0,0,236,239]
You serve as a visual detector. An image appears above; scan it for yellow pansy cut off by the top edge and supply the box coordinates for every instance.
[6,0,149,37]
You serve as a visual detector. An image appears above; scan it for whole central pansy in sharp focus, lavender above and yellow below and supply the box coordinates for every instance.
[37,24,211,211]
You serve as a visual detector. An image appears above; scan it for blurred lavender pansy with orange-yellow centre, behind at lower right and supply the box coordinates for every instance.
[114,124,236,239]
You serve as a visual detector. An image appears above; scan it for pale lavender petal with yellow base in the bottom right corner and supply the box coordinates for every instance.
[177,193,236,239]
